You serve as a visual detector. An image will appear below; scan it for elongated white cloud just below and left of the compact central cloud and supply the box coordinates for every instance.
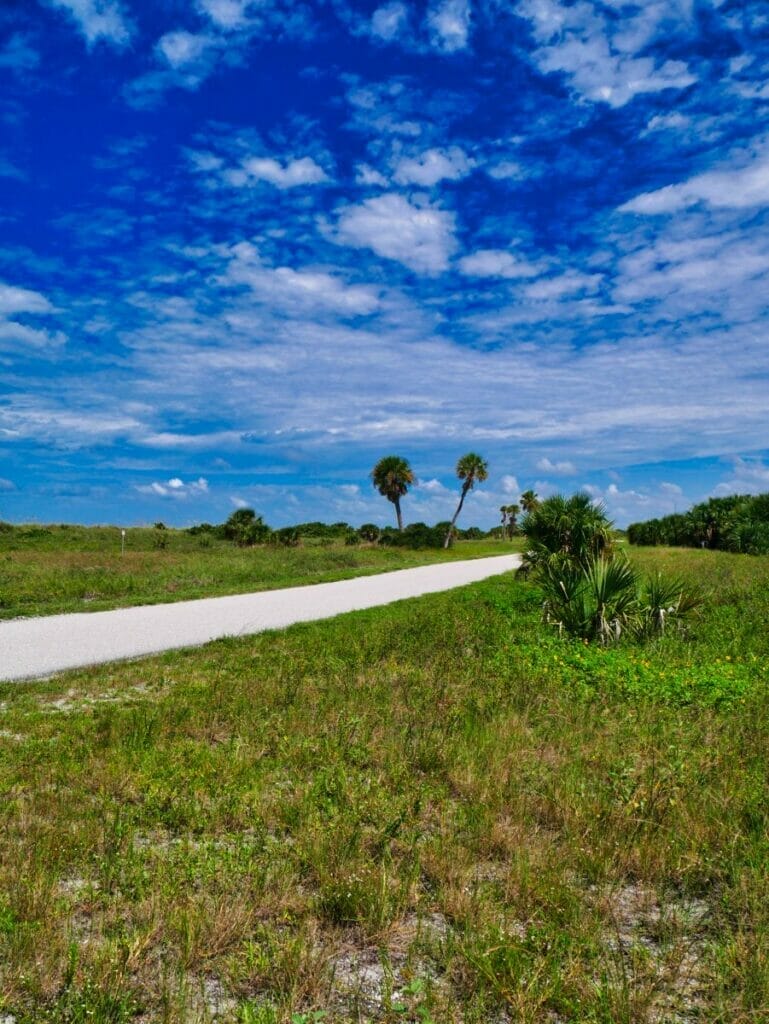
[222,242,380,315]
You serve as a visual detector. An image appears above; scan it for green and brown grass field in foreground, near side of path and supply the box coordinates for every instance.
[0,549,769,1024]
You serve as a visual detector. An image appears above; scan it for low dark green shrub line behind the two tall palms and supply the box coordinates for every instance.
[187,509,493,548]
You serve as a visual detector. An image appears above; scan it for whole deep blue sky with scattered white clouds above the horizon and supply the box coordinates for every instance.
[0,0,769,525]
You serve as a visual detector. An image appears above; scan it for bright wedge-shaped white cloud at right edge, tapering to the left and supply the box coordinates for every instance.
[620,144,769,214]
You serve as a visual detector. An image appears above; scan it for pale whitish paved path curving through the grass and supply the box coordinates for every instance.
[0,555,520,680]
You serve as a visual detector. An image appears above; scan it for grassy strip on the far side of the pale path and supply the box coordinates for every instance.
[0,526,516,618]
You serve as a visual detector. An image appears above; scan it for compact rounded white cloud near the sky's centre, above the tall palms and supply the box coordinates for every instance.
[335,193,457,274]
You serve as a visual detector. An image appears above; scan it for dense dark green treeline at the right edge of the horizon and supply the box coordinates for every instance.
[628,494,769,555]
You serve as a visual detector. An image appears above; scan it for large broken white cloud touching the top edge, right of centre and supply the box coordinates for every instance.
[516,0,696,106]
